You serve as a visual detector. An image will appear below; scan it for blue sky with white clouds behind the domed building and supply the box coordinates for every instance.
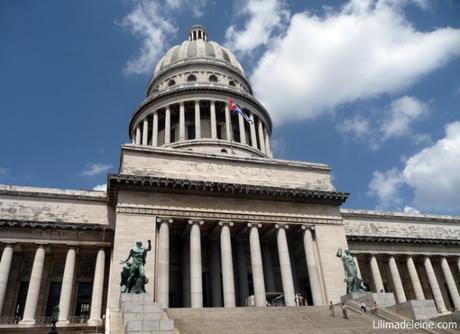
[0,0,460,215]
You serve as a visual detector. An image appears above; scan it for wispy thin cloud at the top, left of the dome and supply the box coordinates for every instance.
[119,0,179,74]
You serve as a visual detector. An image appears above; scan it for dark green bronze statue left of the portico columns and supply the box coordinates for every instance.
[120,240,152,293]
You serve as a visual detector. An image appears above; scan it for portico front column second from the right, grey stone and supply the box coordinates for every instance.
[275,224,296,306]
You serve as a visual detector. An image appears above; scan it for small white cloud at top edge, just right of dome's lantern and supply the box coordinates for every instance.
[225,0,289,54]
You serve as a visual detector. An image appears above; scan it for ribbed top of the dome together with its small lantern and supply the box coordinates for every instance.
[154,25,246,76]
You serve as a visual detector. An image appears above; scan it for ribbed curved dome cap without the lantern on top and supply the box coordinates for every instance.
[154,39,244,74]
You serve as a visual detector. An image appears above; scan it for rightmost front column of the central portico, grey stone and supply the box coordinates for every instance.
[302,226,324,305]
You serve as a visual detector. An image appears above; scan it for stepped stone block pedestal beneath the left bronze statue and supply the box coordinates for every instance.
[120,293,174,334]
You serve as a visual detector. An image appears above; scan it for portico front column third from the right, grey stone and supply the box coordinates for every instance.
[248,224,267,306]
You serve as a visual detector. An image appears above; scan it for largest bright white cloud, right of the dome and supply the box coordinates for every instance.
[251,0,460,124]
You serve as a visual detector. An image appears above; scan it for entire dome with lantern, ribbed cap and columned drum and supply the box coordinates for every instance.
[129,25,272,157]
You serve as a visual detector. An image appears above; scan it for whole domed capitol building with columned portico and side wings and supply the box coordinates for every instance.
[0,25,460,334]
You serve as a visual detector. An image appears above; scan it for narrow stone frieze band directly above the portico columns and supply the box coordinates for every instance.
[116,206,343,225]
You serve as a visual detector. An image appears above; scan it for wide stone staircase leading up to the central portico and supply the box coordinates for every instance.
[166,306,426,334]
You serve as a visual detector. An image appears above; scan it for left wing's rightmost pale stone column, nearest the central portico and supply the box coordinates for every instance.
[88,248,105,326]
